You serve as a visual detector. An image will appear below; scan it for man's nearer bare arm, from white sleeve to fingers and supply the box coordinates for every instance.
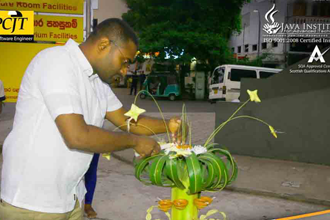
[55,114,160,156]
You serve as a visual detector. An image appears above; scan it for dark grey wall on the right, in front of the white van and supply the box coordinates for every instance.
[215,50,330,165]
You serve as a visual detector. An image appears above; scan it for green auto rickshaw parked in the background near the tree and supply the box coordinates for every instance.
[140,73,181,101]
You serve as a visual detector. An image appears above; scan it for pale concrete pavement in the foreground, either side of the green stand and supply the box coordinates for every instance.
[85,156,330,220]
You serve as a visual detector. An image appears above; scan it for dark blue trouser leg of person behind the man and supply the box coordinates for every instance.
[85,154,100,204]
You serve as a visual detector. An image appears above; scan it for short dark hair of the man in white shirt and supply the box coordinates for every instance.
[89,18,139,47]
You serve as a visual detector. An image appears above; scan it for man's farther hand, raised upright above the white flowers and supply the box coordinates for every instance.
[168,117,189,145]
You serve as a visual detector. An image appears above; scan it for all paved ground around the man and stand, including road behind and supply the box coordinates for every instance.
[0,89,330,220]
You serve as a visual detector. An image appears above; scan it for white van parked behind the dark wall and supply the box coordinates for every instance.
[209,65,282,102]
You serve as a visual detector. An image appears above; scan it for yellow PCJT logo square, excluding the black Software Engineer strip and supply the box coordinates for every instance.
[0,11,34,36]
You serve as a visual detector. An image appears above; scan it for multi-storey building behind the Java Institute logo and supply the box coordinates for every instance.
[229,0,330,68]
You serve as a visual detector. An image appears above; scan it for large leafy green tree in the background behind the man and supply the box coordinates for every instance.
[123,0,247,67]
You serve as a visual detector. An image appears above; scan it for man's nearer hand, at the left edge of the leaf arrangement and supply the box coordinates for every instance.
[134,136,160,158]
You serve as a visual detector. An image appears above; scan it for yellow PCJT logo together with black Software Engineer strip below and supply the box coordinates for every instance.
[0,11,34,42]
